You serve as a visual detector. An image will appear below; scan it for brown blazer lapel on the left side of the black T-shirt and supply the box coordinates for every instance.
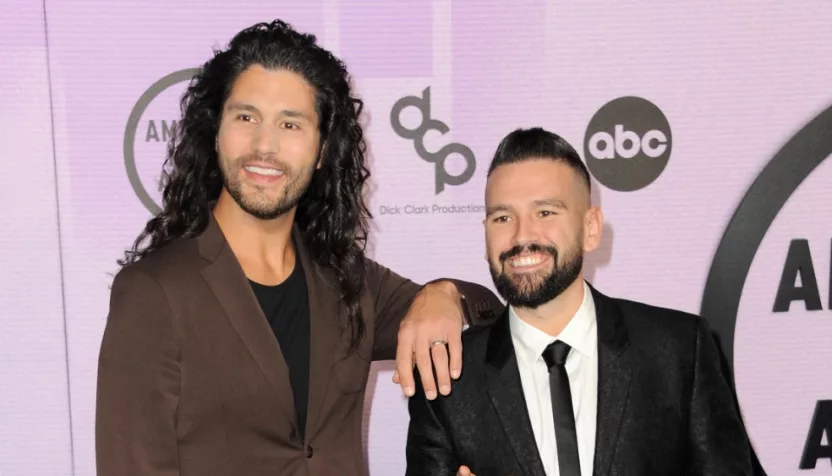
[198,215,298,431]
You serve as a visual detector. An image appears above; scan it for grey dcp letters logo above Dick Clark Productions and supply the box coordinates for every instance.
[390,86,477,195]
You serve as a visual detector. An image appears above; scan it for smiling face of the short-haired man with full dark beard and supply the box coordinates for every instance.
[485,158,601,309]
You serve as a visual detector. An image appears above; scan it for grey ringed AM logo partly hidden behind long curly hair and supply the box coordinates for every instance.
[124,69,199,215]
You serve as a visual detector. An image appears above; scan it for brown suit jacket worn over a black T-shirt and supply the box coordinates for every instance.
[96,217,502,476]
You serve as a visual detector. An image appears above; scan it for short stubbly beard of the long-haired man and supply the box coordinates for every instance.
[220,154,317,220]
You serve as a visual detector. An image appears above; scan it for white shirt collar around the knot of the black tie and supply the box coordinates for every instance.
[509,281,598,362]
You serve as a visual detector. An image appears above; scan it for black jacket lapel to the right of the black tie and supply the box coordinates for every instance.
[590,287,631,476]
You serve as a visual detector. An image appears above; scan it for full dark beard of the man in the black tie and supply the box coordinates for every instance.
[489,240,584,309]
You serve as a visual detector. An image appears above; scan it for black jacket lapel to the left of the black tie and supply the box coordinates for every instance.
[486,308,546,476]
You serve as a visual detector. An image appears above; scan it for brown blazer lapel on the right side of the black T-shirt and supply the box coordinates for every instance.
[292,228,342,439]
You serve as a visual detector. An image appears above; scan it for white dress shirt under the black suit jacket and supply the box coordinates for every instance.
[509,282,598,476]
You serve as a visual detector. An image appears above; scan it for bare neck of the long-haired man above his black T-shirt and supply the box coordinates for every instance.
[214,190,295,285]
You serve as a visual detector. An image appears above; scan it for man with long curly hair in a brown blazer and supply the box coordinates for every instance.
[96,21,501,476]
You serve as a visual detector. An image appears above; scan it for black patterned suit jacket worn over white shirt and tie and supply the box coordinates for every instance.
[406,287,754,476]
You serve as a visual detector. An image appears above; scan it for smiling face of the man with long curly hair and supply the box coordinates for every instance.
[217,65,320,220]
